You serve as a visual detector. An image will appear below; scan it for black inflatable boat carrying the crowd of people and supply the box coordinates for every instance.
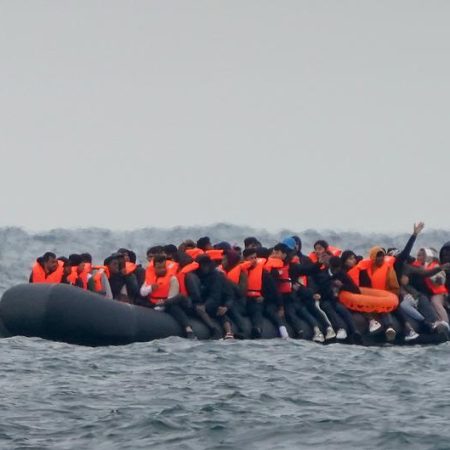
[0,284,448,346]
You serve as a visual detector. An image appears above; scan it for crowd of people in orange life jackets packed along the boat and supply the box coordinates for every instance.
[30,223,450,343]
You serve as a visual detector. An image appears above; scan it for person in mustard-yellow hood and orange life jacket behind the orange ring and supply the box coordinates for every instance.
[358,247,400,342]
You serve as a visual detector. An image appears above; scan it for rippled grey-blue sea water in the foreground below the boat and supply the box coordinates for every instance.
[0,337,450,450]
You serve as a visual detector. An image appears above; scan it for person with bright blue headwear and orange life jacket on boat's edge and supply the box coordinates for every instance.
[271,241,324,342]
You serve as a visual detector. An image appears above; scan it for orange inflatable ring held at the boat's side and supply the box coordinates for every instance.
[339,288,398,313]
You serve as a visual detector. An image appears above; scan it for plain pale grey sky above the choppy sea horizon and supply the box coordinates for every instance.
[0,0,450,231]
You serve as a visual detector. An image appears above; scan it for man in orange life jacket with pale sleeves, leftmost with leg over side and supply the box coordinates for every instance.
[140,255,195,339]
